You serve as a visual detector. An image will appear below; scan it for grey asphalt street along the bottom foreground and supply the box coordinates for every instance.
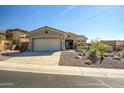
[0,70,124,88]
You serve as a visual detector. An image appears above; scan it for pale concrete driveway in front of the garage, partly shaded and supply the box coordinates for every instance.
[6,51,61,65]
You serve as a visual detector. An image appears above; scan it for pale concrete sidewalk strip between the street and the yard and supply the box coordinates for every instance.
[0,62,124,78]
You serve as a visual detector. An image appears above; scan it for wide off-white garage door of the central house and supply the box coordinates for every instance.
[34,39,61,51]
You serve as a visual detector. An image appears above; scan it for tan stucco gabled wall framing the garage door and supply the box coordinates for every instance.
[28,28,65,50]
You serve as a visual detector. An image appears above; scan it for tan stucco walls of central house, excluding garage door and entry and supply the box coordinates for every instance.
[28,27,86,50]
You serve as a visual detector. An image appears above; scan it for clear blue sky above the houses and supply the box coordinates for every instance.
[0,5,124,40]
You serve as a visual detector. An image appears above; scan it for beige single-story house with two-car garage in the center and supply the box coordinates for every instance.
[28,26,87,51]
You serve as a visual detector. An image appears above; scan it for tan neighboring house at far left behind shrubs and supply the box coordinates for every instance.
[0,28,29,48]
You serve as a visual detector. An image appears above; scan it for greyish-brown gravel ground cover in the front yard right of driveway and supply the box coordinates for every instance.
[59,52,124,69]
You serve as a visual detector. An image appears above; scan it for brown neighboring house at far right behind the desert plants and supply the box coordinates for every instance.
[101,40,124,50]
